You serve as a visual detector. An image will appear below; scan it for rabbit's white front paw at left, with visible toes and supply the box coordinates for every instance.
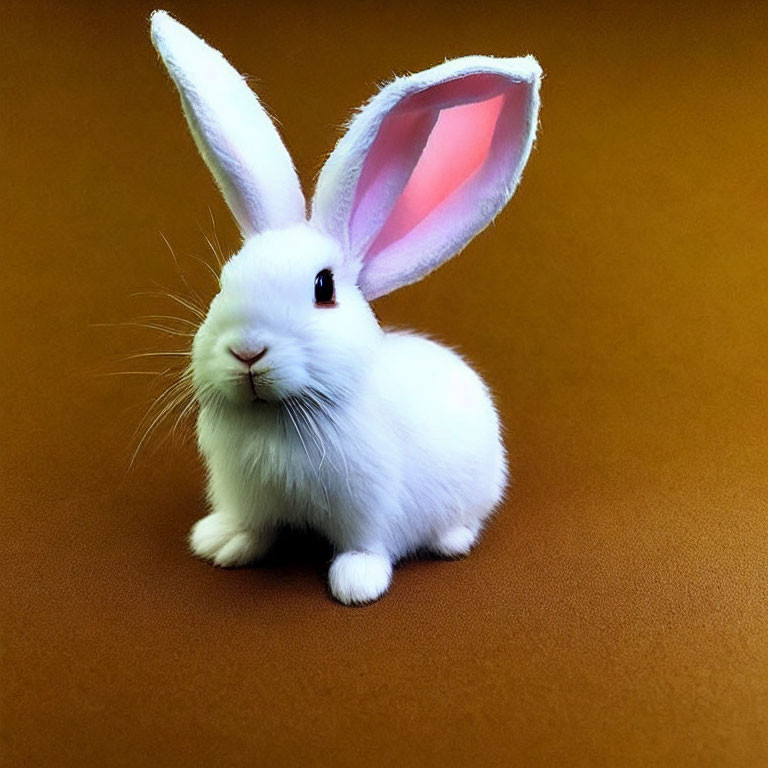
[189,512,272,568]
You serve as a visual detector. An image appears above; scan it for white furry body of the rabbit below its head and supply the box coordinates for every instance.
[191,332,506,602]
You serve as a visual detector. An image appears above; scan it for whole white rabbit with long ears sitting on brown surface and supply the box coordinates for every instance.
[151,11,541,603]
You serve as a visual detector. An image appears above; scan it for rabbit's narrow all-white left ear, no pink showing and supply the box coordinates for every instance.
[151,11,306,237]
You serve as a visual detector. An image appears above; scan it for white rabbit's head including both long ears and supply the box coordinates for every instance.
[152,11,541,403]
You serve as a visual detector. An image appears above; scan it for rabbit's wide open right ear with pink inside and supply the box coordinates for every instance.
[312,56,541,299]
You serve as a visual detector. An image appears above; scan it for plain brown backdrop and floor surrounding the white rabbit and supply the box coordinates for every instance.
[0,0,768,768]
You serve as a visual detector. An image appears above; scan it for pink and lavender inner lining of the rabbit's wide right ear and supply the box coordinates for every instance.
[349,72,530,269]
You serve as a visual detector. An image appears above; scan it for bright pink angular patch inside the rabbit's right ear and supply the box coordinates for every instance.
[369,94,504,253]
